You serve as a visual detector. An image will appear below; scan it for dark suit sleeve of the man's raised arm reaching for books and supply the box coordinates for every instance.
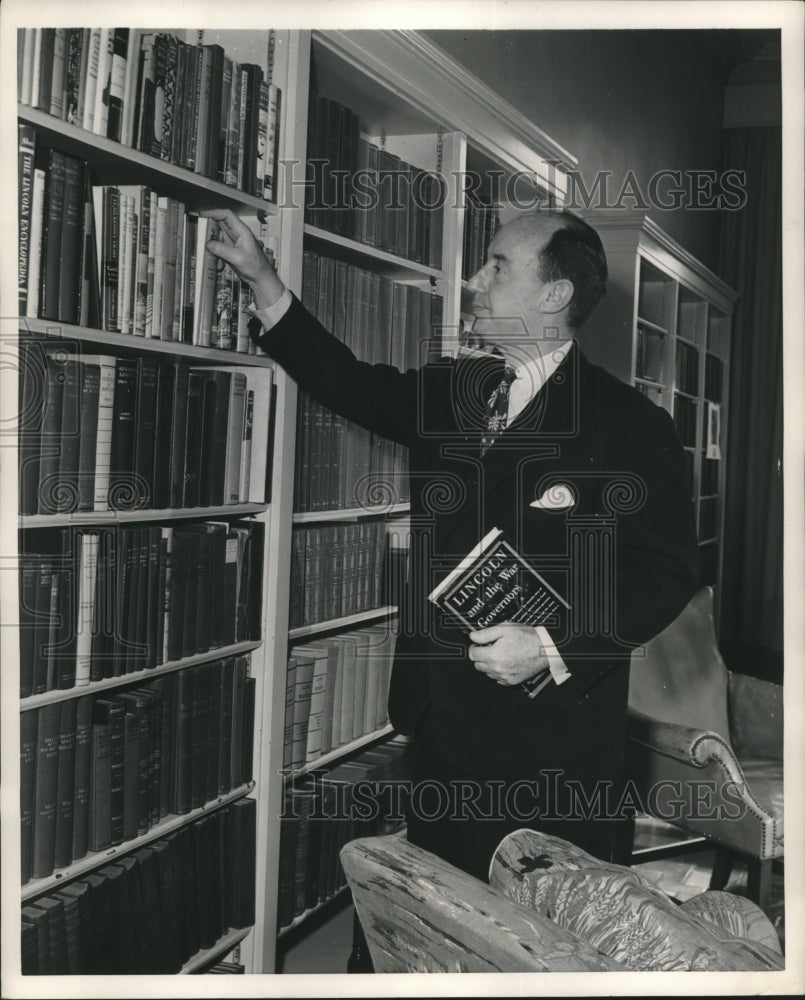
[255,298,419,446]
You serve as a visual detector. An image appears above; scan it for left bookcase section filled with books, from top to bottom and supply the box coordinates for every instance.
[11,21,286,974]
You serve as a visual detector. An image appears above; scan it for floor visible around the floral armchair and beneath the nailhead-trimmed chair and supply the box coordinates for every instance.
[277,821,785,973]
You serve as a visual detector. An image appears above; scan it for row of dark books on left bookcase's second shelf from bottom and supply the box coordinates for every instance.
[20,657,255,884]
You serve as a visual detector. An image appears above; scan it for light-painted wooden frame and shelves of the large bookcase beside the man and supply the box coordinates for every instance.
[4,23,575,973]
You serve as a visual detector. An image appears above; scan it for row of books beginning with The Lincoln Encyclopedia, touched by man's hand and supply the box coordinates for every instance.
[18,123,274,344]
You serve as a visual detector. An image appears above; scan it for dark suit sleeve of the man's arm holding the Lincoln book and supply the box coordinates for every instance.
[558,401,699,689]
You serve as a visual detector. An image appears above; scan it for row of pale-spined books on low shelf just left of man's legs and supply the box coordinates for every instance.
[283,625,396,769]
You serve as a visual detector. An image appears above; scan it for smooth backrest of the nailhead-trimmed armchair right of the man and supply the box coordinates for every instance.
[629,587,730,743]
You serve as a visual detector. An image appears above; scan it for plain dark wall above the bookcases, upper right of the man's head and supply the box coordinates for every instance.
[426,31,725,270]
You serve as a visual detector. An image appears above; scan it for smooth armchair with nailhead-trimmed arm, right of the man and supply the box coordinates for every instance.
[627,587,783,912]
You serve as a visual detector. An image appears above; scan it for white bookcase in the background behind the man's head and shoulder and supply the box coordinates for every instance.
[579,211,737,600]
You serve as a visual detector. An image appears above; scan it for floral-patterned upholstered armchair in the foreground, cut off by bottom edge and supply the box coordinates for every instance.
[341,830,783,973]
